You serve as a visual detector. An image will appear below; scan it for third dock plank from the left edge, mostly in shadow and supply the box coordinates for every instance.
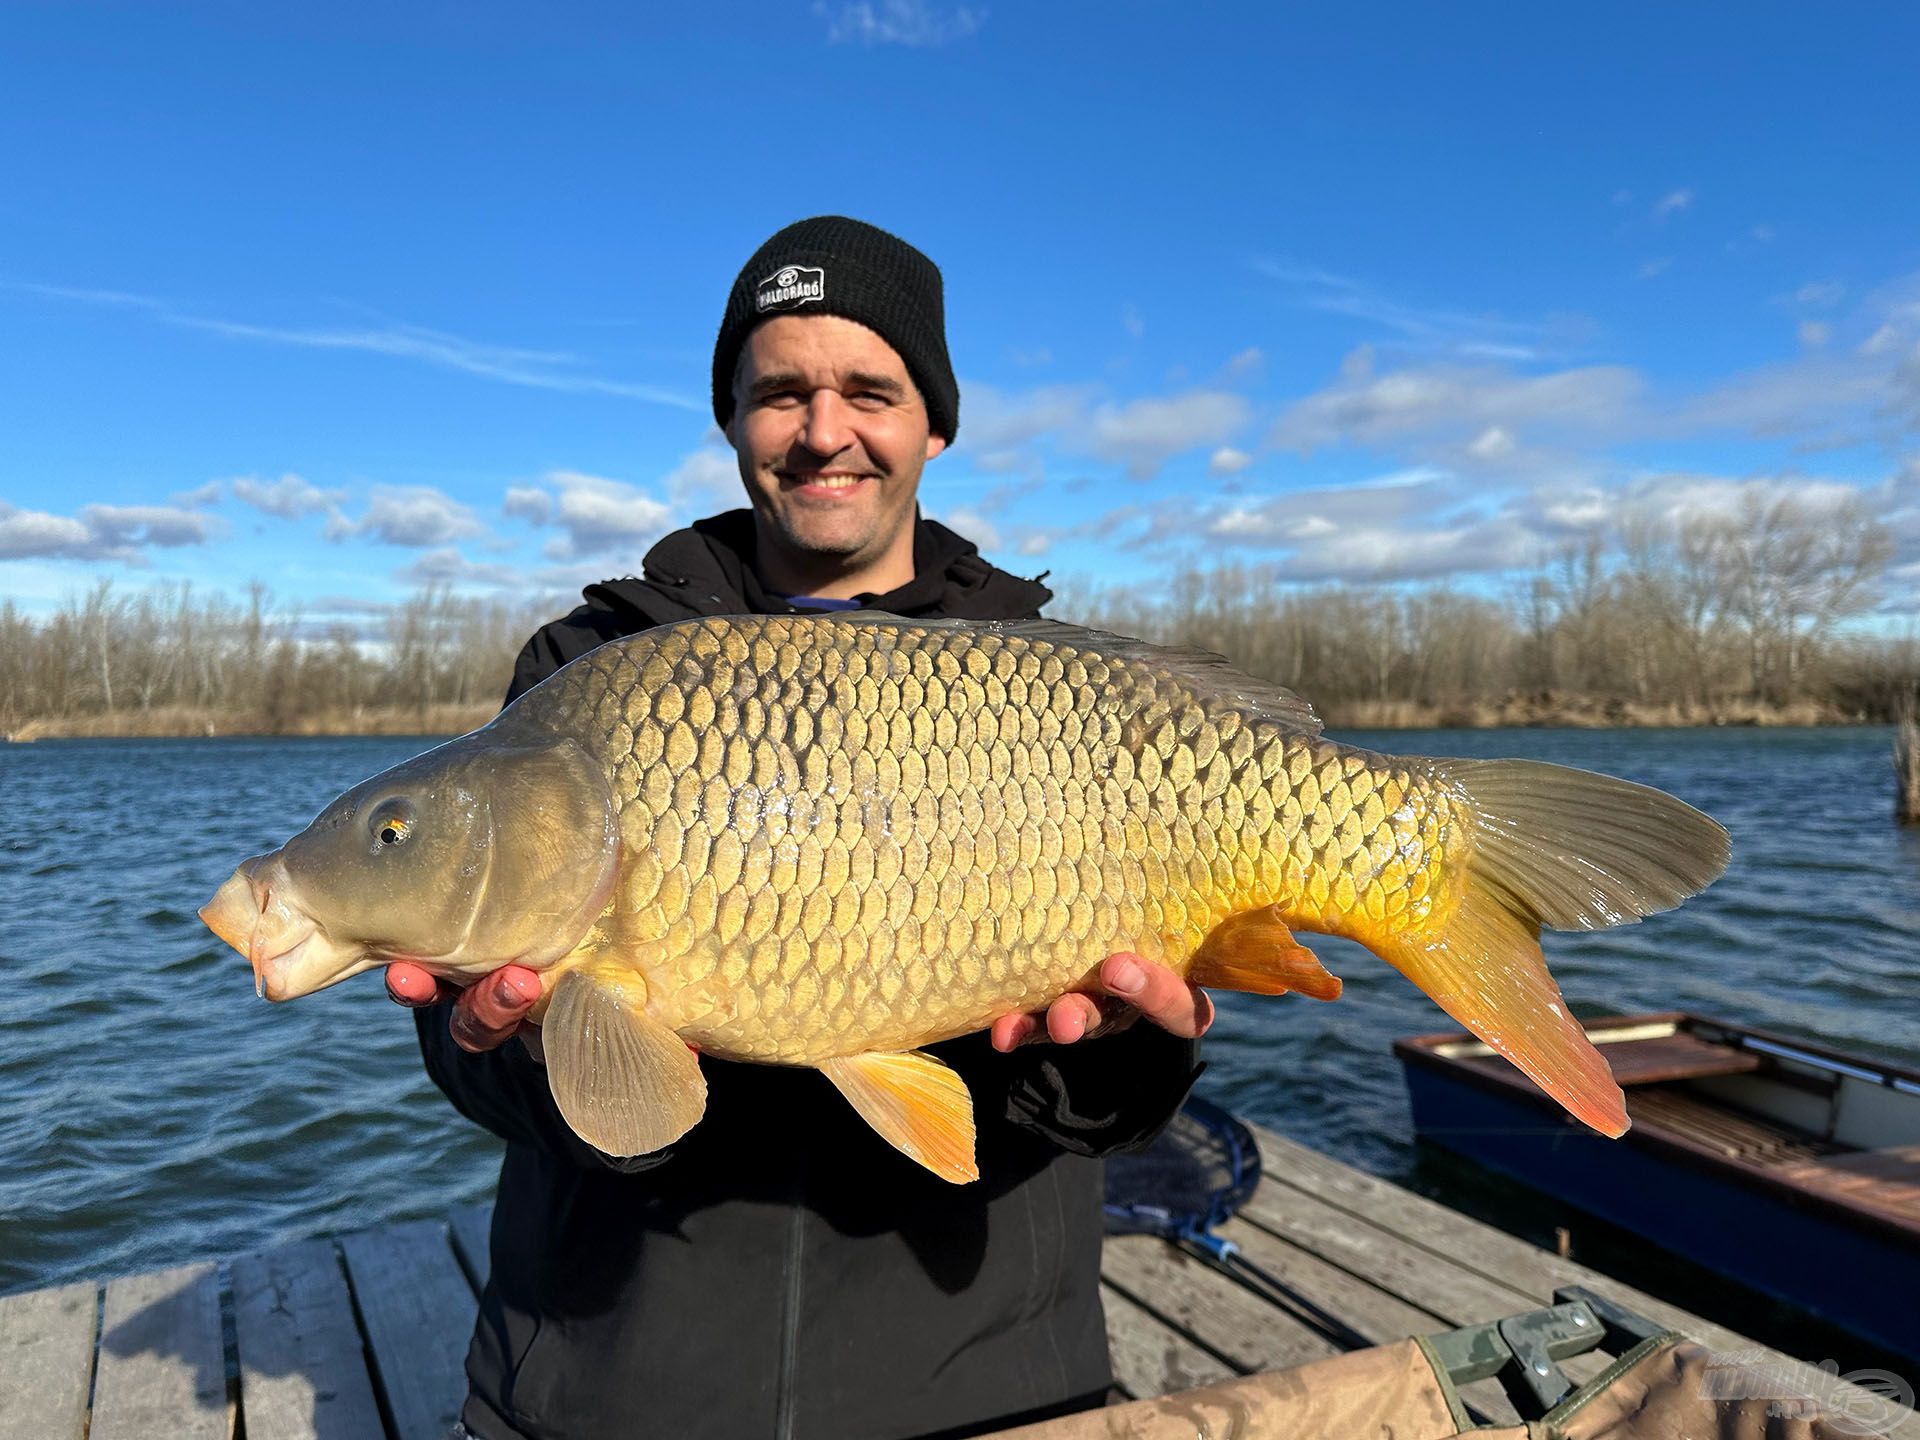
[232,1240,386,1440]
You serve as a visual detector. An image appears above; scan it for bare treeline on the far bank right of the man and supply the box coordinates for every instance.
[1056,497,1920,724]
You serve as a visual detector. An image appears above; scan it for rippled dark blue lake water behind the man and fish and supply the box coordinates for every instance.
[0,730,1920,1292]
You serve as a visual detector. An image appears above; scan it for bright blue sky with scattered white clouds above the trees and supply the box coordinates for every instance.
[0,0,1920,618]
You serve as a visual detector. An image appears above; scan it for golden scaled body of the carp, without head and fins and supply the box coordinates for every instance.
[522,616,1457,1064]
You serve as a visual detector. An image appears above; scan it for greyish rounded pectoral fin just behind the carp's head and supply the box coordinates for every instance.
[540,970,707,1156]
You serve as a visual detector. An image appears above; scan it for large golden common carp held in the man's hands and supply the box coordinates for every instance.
[202,612,1728,1181]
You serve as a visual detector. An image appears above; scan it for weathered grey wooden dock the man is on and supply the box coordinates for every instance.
[0,1131,1920,1440]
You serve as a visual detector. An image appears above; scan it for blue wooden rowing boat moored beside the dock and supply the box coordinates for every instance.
[1394,1012,1920,1361]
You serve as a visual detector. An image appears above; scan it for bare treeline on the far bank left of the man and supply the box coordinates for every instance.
[0,582,553,733]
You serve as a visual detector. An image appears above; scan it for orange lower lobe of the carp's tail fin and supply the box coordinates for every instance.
[1380,887,1632,1137]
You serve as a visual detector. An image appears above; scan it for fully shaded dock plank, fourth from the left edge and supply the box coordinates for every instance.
[340,1219,478,1440]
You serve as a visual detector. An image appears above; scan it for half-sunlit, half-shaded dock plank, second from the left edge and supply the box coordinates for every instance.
[88,1263,232,1440]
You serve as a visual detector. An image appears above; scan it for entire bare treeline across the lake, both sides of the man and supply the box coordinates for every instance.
[0,499,1920,735]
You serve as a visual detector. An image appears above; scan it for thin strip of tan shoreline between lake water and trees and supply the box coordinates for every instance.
[0,695,1893,745]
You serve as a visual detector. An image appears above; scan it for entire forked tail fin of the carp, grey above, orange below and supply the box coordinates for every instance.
[1379,760,1730,1135]
